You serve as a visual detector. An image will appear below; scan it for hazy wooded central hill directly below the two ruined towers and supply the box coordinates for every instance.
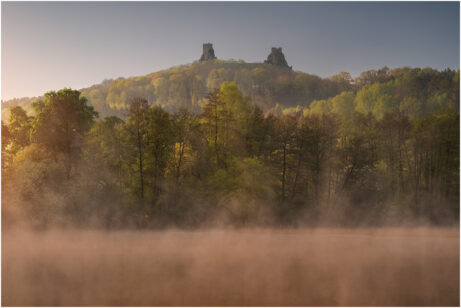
[2,59,360,120]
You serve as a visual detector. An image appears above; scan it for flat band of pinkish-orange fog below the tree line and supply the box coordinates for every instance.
[2,228,459,306]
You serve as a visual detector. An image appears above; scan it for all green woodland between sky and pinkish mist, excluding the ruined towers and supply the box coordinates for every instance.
[2,65,460,228]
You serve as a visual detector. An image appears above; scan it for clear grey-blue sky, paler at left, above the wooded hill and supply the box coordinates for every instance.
[1,2,460,100]
